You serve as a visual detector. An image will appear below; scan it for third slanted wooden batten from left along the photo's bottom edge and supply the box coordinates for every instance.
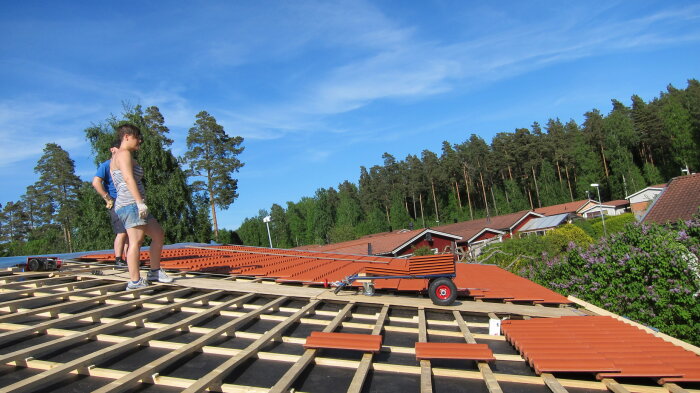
[183,300,320,392]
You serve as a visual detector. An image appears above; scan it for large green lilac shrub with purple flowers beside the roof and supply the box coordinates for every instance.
[520,218,700,345]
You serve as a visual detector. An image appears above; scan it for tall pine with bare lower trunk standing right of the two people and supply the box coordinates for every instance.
[185,111,244,239]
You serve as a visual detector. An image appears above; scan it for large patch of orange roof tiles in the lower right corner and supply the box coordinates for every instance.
[501,316,700,383]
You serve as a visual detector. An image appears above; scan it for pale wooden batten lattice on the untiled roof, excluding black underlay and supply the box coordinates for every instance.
[0,266,700,393]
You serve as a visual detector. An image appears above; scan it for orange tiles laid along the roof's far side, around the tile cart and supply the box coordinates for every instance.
[84,246,571,304]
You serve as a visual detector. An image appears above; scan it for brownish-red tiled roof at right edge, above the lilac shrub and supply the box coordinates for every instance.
[642,173,700,224]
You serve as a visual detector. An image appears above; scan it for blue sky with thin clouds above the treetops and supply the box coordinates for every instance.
[0,0,700,229]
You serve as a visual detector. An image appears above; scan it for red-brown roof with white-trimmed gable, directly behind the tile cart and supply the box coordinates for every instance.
[295,228,461,255]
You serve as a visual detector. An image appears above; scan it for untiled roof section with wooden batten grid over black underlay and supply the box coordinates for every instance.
[0,266,700,393]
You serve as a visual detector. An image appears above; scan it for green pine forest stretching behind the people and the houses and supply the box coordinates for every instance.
[0,79,700,256]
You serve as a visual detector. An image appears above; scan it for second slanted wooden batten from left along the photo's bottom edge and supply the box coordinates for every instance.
[95,297,288,393]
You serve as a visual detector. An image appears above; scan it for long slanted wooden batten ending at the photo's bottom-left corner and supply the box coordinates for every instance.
[0,294,254,392]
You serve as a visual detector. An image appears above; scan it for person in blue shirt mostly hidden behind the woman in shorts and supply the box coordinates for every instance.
[92,140,129,267]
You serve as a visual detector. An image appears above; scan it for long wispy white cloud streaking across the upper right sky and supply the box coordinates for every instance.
[200,2,700,139]
